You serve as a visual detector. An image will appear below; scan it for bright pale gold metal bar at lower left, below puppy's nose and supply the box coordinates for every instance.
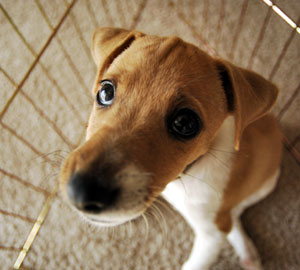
[13,184,58,270]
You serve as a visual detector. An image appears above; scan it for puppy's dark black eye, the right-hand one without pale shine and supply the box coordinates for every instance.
[167,108,203,139]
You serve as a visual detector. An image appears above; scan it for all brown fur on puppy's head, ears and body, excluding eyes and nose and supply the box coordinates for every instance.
[60,28,280,231]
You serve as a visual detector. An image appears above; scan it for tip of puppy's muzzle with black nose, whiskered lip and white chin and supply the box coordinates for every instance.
[65,161,156,227]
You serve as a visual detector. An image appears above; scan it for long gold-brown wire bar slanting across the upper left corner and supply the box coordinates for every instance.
[0,0,77,119]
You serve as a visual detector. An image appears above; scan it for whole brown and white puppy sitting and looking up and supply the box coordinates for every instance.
[60,28,282,270]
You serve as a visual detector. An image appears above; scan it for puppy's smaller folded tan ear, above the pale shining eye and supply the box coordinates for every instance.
[92,27,144,74]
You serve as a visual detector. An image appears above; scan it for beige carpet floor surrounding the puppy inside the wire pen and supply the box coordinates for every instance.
[0,0,300,270]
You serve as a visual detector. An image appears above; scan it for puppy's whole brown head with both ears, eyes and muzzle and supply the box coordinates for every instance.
[60,28,276,226]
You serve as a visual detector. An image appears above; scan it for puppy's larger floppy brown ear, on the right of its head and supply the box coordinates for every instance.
[217,60,278,150]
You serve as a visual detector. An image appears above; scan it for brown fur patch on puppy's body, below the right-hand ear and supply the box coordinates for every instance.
[216,115,282,233]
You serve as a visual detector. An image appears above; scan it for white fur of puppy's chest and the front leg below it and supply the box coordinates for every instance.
[163,117,235,270]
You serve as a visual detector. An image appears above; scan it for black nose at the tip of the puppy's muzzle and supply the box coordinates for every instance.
[67,173,119,214]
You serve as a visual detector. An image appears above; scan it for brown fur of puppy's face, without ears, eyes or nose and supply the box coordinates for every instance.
[61,29,227,205]
